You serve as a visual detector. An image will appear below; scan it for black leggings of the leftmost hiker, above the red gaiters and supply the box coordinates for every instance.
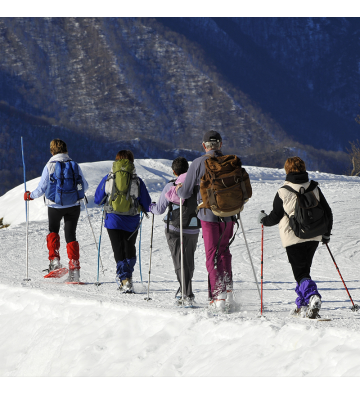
[48,205,80,243]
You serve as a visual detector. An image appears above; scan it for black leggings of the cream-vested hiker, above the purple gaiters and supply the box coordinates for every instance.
[286,241,319,284]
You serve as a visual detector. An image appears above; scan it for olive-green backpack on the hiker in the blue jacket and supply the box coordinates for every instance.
[105,159,142,215]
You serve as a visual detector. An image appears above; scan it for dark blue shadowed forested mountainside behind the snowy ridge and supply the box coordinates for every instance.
[0,18,358,194]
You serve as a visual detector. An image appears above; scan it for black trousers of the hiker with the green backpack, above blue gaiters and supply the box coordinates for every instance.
[107,229,138,263]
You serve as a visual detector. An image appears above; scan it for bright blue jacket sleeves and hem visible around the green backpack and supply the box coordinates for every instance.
[94,175,151,232]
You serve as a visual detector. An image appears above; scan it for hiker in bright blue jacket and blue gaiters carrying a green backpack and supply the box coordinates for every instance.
[94,150,151,293]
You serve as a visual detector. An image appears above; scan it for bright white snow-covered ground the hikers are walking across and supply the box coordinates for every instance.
[0,159,360,382]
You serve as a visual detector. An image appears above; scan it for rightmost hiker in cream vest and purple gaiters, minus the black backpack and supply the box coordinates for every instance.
[258,156,333,318]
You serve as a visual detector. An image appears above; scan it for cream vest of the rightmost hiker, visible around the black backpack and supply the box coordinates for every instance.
[278,181,321,248]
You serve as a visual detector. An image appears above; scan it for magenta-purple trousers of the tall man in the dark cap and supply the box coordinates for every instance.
[201,221,234,298]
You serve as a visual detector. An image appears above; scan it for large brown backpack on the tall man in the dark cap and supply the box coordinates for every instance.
[198,155,252,217]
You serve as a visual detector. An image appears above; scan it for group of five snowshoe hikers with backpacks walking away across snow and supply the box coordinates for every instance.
[24,130,333,318]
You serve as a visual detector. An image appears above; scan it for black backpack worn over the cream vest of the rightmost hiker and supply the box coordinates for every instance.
[282,181,329,239]
